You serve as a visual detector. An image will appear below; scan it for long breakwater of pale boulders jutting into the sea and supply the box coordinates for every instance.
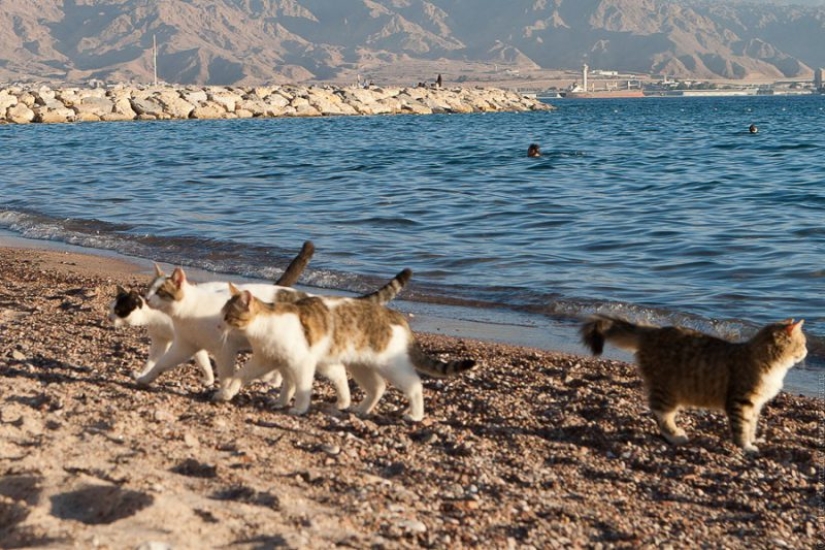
[0,86,552,124]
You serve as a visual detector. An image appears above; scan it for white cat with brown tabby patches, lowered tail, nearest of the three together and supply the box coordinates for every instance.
[221,272,475,422]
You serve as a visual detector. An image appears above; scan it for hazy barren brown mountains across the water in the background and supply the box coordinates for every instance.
[0,0,825,85]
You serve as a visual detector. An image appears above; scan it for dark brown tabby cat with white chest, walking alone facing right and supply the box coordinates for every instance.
[580,315,808,452]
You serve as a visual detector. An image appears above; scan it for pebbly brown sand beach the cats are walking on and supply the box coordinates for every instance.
[0,246,825,550]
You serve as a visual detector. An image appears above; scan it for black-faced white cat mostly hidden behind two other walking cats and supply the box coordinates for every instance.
[109,241,315,386]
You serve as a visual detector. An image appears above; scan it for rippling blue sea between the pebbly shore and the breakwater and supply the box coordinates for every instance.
[0,96,825,395]
